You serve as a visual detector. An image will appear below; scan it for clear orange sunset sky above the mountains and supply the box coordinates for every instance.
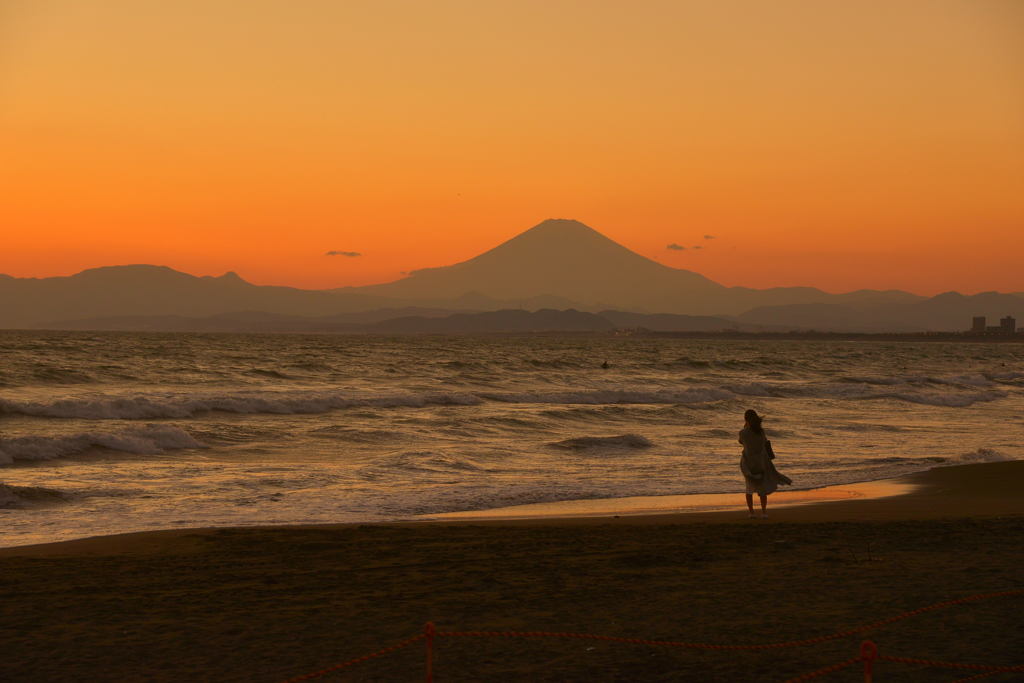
[0,0,1024,294]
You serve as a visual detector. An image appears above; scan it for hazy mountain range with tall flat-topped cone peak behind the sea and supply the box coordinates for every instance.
[0,219,1024,332]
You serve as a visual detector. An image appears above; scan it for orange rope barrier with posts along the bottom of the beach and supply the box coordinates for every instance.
[285,589,1024,683]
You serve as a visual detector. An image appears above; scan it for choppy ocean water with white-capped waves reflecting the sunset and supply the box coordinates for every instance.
[0,331,1024,546]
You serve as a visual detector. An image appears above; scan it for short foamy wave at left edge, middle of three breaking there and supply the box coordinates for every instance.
[0,425,206,465]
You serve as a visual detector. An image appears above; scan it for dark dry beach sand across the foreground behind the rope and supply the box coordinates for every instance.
[0,462,1024,681]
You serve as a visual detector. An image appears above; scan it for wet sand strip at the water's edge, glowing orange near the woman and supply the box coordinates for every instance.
[0,460,1024,558]
